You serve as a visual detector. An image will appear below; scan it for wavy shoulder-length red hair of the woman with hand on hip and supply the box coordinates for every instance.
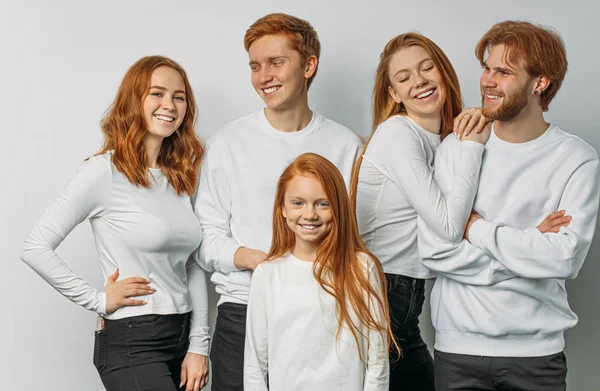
[97,56,204,196]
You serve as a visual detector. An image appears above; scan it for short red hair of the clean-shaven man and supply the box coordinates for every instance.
[244,13,321,88]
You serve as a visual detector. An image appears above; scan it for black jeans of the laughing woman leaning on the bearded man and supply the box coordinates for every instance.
[385,274,435,391]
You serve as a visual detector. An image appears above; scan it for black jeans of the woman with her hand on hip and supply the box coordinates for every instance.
[94,313,190,391]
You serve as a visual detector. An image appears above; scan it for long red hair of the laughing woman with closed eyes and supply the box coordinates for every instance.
[350,32,463,210]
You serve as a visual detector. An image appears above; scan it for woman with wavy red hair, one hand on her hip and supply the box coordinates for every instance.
[21,56,209,391]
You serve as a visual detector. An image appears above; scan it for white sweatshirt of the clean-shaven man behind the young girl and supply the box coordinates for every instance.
[195,110,362,305]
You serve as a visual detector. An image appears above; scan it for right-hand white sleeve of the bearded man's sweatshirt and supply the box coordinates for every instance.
[469,159,600,279]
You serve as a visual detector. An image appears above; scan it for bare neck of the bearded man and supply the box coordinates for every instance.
[494,107,550,144]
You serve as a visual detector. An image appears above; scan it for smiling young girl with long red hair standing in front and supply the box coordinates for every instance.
[244,153,397,391]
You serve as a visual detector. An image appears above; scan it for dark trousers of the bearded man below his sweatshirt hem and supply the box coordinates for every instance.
[435,350,567,391]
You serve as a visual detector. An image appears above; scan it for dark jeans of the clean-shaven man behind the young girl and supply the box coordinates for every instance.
[210,303,248,391]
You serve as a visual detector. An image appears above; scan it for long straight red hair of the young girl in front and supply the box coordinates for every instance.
[267,153,400,363]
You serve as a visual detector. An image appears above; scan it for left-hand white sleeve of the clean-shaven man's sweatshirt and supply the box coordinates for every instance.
[194,143,240,273]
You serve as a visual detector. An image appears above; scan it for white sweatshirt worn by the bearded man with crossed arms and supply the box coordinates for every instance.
[418,125,600,357]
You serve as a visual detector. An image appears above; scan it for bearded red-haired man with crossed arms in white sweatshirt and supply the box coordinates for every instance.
[419,21,600,391]
